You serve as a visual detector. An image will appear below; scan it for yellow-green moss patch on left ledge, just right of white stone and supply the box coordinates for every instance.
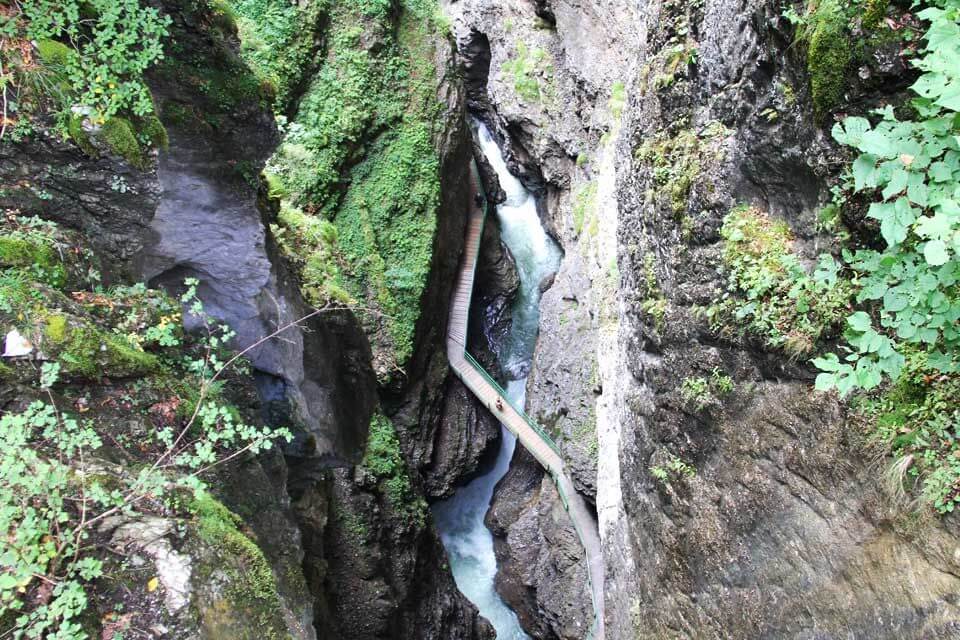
[43,314,159,378]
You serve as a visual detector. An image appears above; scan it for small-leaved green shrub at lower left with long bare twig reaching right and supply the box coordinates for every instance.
[0,280,354,640]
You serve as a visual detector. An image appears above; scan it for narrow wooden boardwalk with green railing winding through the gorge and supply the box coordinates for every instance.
[447,162,604,640]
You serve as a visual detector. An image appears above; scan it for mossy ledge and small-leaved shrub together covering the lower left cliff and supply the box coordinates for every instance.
[0,211,289,640]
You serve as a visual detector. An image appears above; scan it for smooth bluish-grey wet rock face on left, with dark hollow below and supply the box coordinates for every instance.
[138,10,376,464]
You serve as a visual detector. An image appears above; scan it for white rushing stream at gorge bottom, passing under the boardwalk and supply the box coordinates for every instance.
[433,123,561,640]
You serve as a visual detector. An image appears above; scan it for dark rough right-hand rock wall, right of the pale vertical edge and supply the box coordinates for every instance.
[604,1,960,638]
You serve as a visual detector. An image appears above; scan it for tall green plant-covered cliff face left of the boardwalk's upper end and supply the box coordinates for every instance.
[248,0,447,375]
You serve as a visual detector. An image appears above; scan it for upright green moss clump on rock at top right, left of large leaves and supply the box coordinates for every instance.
[807,0,854,118]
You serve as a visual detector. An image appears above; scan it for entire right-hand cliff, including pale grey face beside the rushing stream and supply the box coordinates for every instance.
[448,0,960,638]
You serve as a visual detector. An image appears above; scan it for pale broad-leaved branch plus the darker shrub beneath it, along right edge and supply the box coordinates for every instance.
[814,0,960,512]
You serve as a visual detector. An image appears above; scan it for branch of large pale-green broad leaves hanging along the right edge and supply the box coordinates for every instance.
[814,0,960,395]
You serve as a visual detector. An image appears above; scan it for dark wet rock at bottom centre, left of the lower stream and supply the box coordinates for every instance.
[294,467,494,640]
